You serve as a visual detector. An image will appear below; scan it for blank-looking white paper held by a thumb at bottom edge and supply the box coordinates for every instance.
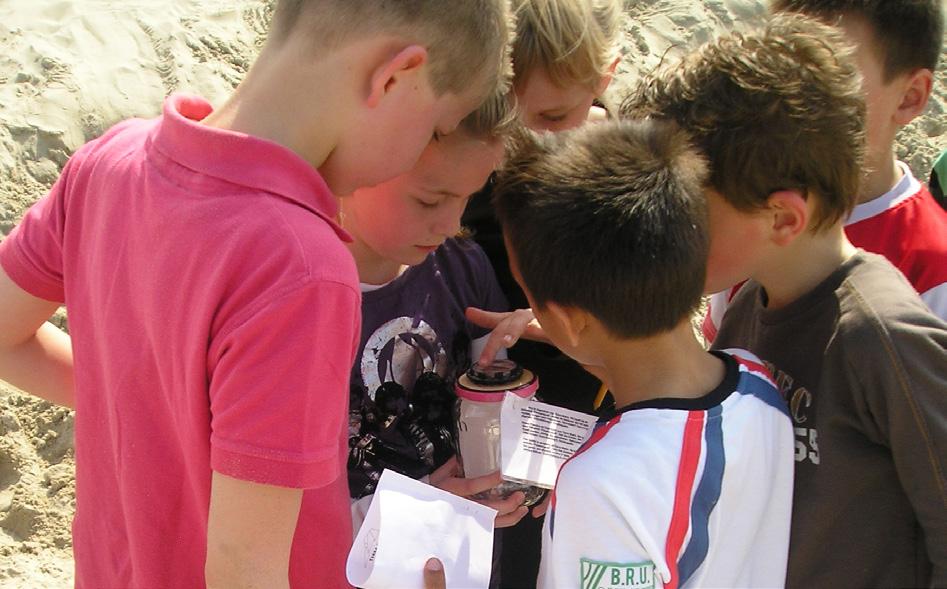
[346,470,497,589]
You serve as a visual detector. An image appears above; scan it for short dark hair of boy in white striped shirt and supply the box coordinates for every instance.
[493,121,708,338]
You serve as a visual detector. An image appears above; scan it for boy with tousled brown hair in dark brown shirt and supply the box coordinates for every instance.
[623,15,947,587]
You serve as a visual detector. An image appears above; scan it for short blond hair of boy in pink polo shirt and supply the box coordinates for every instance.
[270,0,515,96]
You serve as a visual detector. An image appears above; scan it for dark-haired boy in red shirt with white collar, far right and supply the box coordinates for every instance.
[704,0,947,330]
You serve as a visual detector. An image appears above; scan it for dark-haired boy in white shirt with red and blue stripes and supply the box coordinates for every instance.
[494,121,792,587]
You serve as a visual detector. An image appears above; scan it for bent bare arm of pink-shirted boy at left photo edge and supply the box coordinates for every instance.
[0,268,75,407]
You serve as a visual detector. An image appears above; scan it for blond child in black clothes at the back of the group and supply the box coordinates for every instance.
[463,0,623,587]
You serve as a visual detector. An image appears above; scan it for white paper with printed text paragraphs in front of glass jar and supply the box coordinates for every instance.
[500,393,596,489]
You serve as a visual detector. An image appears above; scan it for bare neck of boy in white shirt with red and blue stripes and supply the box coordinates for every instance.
[603,320,725,407]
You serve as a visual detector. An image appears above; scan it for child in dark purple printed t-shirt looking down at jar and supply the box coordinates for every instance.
[341,94,526,527]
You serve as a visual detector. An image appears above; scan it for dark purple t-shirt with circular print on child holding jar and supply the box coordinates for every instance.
[348,239,509,499]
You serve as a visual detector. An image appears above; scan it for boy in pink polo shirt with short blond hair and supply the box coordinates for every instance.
[0,0,511,588]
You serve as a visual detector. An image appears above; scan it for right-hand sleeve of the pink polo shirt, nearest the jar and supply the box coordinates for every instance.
[209,281,360,489]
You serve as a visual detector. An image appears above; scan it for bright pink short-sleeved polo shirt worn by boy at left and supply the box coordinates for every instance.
[0,95,360,588]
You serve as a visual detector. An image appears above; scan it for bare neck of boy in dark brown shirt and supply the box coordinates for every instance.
[753,221,858,309]
